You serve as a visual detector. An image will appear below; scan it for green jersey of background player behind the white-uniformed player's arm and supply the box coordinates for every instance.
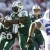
[31,15,44,45]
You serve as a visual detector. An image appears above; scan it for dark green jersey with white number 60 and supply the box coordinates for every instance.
[0,25,17,40]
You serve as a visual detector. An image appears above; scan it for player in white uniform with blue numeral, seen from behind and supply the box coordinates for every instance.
[27,9,50,50]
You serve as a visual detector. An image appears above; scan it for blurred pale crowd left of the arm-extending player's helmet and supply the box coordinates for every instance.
[0,0,15,16]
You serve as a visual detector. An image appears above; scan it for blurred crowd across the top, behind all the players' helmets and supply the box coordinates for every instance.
[0,0,50,16]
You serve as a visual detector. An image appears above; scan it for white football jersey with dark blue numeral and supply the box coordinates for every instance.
[35,18,50,41]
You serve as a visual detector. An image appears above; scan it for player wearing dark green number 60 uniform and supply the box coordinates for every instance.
[0,17,18,50]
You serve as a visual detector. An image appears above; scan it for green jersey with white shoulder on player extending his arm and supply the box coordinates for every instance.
[18,11,31,36]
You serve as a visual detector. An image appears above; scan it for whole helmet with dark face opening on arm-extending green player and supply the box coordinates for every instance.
[12,1,23,12]
